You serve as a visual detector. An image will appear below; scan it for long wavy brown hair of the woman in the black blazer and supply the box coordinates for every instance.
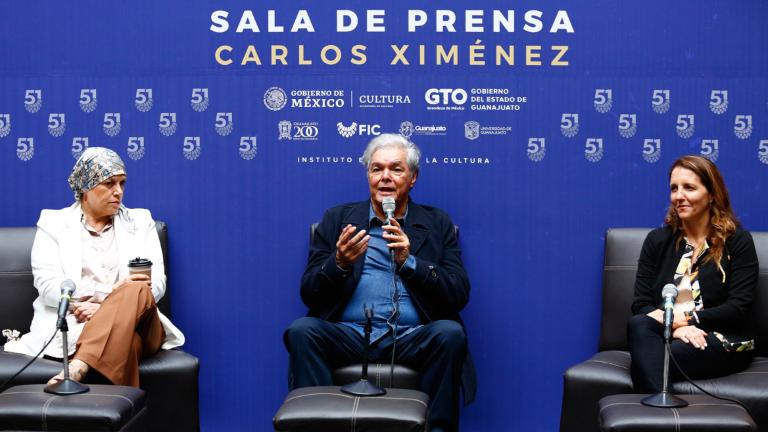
[664,155,739,281]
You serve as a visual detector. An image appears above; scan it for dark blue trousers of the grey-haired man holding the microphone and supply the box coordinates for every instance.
[283,317,467,431]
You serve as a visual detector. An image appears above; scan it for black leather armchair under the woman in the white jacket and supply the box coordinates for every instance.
[0,221,200,432]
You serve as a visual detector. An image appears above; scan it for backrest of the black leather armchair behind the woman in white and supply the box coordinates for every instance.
[0,221,171,336]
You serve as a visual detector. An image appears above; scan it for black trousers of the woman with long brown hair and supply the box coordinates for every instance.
[627,315,753,393]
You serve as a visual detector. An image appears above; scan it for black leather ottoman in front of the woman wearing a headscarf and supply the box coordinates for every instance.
[0,384,146,432]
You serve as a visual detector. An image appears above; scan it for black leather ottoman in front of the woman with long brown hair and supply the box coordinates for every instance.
[598,394,757,432]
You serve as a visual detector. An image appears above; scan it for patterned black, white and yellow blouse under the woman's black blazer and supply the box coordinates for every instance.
[674,238,755,352]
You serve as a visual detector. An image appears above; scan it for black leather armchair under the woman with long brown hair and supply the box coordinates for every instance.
[560,228,768,432]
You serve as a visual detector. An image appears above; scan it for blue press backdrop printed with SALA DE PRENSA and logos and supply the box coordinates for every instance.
[0,0,768,431]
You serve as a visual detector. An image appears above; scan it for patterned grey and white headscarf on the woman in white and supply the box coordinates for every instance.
[69,147,125,201]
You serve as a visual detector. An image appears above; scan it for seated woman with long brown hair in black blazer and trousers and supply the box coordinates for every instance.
[627,156,758,393]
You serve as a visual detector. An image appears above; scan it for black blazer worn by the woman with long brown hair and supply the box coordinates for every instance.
[632,226,759,341]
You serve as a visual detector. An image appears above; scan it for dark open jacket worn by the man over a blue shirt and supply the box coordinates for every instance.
[301,201,476,403]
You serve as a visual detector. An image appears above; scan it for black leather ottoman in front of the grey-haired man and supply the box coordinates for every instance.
[273,387,429,432]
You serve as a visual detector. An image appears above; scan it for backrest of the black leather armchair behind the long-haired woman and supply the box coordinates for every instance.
[599,228,768,355]
